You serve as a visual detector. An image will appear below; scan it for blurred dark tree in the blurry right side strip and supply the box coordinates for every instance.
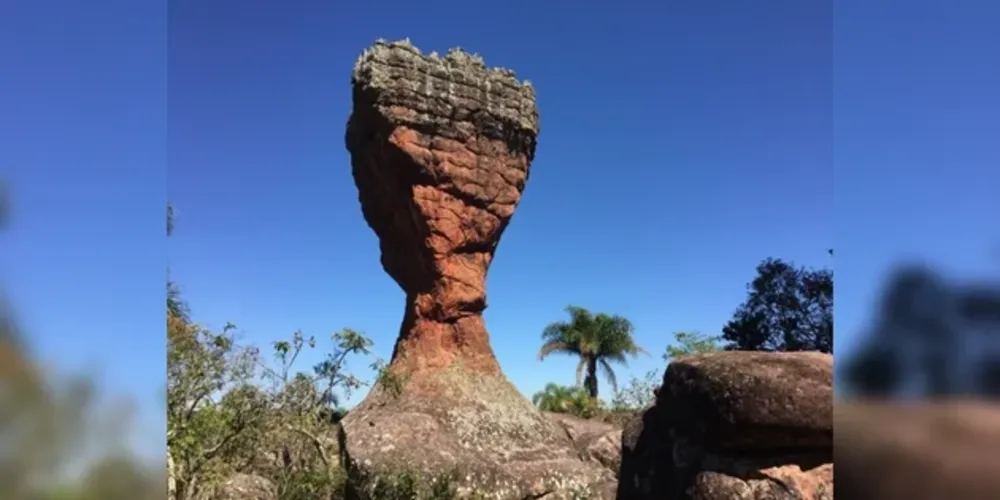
[837,265,1000,398]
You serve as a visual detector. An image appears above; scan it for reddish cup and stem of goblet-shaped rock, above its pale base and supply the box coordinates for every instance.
[346,38,538,373]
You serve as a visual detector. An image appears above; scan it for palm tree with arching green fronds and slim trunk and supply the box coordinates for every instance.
[538,306,645,398]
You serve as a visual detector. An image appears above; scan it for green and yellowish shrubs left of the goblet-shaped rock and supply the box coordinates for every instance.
[161,205,384,500]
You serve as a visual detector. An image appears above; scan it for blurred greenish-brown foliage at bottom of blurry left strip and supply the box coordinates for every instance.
[0,302,165,500]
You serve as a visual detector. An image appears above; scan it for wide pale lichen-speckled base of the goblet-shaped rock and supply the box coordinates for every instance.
[341,363,615,500]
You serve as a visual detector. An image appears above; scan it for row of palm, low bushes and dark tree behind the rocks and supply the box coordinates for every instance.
[532,254,833,418]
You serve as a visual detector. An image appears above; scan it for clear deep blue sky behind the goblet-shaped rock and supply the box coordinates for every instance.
[0,0,1000,462]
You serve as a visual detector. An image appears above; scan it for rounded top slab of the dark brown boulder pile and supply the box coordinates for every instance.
[661,351,833,449]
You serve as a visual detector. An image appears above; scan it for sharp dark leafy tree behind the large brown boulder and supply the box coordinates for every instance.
[722,258,833,353]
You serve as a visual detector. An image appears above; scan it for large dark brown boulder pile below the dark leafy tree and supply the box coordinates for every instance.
[618,352,833,500]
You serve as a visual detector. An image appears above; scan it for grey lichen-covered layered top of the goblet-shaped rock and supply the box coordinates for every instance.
[352,40,539,138]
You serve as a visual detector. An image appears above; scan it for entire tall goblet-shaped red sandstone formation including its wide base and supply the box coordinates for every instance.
[341,41,614,498]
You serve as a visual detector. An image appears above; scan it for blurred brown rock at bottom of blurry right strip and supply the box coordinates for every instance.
[834,400,1000,499]
